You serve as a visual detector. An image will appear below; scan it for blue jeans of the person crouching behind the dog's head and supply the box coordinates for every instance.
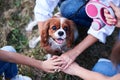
[60,0,92,28]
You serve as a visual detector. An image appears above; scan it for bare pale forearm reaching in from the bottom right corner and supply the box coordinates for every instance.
[63,63,120,80]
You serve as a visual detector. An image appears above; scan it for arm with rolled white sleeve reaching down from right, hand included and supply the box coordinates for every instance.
[61,16,115,69]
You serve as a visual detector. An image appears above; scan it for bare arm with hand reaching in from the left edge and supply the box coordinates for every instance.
[0,50,62,73]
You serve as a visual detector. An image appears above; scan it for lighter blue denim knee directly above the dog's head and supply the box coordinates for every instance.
[60,0,84,18]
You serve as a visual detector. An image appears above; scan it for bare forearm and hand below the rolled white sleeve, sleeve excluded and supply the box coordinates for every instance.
[61,34,98,69]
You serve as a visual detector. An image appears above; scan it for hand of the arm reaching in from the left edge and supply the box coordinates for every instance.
[41,56,63,73]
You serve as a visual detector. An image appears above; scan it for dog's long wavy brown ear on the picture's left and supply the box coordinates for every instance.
[40,20,50,47]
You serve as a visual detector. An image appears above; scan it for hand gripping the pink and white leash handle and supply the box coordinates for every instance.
[104,2,120,27]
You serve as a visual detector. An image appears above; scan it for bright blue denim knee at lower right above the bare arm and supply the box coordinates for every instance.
[92,58,120,76]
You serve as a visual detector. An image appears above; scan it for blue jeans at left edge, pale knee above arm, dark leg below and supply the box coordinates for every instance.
[0,46,18,79]
